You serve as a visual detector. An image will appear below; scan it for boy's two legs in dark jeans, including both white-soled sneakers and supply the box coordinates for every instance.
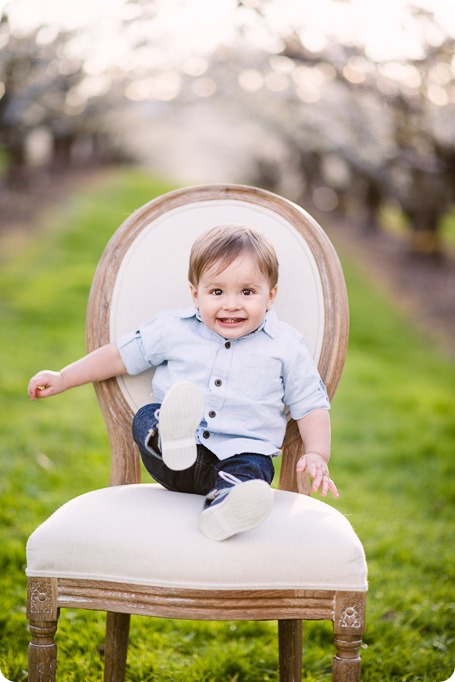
[133,390,274,540]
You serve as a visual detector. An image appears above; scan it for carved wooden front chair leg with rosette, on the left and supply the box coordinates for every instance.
[27,578,59,682]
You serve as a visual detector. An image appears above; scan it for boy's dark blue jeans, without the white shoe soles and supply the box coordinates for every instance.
[133,403,275,497]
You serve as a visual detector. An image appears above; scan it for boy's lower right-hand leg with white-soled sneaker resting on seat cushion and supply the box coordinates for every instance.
[199,454,274,540]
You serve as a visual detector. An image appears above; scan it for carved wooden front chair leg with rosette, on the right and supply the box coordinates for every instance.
[333,592,366,682]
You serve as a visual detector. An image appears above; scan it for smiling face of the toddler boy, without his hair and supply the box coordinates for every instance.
[190,254,277,339]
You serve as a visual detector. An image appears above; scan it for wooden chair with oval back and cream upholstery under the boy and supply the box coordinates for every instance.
[27,185,367,682]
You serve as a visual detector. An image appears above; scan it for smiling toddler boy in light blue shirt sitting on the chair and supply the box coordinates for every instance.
[28,225,338,540]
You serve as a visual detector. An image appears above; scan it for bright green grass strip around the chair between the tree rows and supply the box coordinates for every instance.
[0,166,455,682]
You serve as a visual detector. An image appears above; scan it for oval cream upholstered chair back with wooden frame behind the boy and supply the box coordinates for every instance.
[87,185,348,490]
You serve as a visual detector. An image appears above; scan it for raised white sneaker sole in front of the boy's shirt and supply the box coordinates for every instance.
[158,381,204,471]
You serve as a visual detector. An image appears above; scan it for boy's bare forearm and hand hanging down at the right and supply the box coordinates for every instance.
[296,409,339,497]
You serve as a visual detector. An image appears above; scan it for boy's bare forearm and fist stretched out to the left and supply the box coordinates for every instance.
[27,343,127,400]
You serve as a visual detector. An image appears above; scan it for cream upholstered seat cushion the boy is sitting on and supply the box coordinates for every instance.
[27,484,367,591]
